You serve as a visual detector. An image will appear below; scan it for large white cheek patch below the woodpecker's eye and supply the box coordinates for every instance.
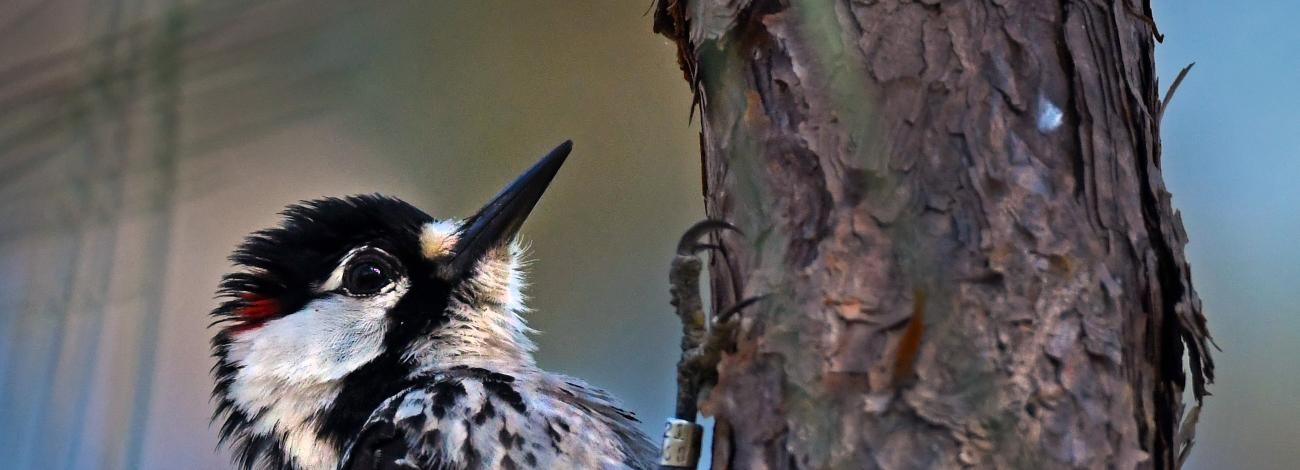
[230,279,411,384]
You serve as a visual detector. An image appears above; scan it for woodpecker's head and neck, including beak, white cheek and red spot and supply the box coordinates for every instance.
[212,142,572,467]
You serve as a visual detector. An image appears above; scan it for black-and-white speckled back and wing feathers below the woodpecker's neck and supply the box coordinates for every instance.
[341,367,654,470]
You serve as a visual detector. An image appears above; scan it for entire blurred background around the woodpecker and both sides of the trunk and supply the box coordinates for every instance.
[0,0,1300,469]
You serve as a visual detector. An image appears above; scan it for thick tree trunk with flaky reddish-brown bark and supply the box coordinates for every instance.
[655,0,1213,469]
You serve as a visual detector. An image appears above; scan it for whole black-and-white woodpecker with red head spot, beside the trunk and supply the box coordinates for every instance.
[212,142,657,470]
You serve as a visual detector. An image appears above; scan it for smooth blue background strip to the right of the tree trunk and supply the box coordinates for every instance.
[1154,0,1300,469]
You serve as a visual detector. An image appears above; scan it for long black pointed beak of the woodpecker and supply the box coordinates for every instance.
[439,140,573,280]
